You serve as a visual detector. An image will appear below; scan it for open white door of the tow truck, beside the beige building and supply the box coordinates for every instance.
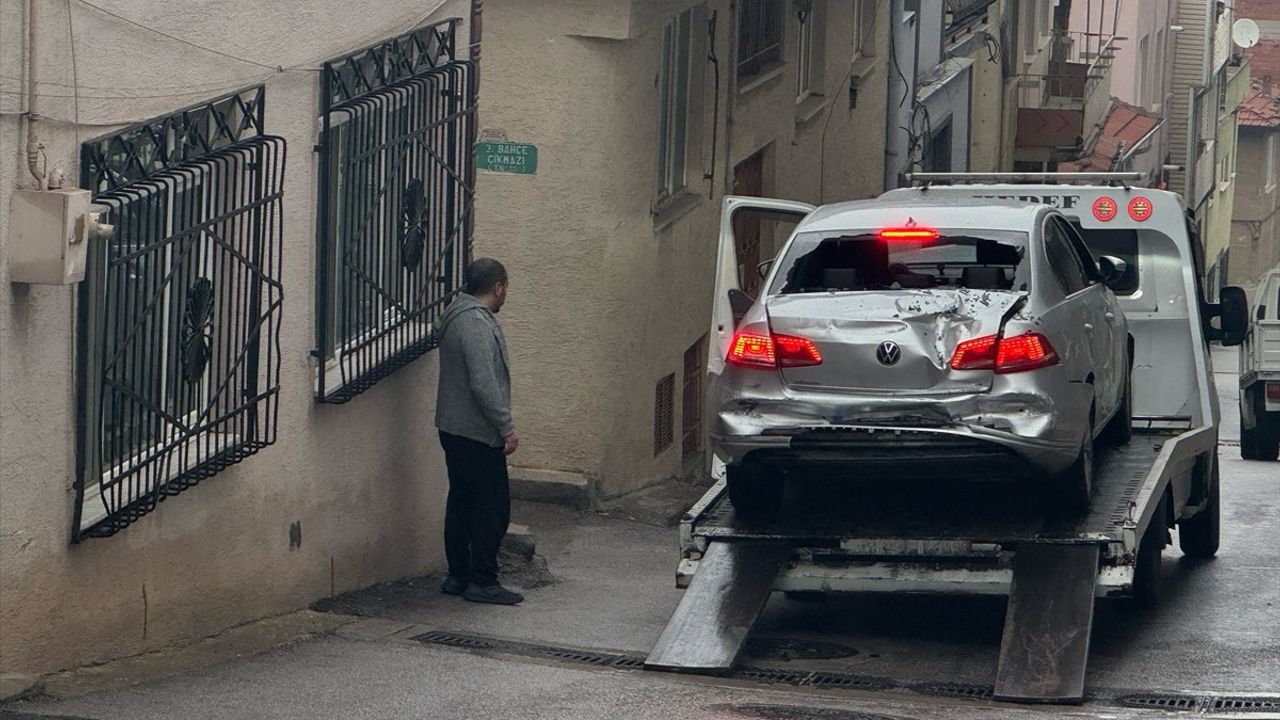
[704,195,814,479]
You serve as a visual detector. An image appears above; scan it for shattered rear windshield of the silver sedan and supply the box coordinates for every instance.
[769,229,1030,295]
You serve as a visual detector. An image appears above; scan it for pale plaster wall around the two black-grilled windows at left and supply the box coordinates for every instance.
[0,0,468,673]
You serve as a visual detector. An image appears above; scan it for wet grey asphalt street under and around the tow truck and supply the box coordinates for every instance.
[0,350,1280,720]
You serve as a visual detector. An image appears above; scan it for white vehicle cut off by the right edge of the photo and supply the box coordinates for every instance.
[1240,266,1280,460]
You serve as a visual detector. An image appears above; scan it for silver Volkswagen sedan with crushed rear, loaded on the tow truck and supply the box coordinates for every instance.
[710,199,1132,521]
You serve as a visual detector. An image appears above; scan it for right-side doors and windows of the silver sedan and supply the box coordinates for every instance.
[1055,218,1128,415]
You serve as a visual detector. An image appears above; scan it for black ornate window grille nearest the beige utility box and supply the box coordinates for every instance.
[72,86,285,542]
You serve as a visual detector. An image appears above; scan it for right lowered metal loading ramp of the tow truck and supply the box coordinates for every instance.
[995,543,1100,702]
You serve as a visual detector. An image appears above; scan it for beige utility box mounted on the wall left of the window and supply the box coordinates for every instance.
[9,188,111,284]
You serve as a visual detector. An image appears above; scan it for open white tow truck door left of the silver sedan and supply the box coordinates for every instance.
[703,195,814,478]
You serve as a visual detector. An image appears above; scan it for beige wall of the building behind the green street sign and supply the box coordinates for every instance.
[477,0,887,496]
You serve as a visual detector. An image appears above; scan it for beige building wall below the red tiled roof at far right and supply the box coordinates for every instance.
[1228,127,1280,292]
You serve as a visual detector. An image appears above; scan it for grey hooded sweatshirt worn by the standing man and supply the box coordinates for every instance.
[435,293,516,447]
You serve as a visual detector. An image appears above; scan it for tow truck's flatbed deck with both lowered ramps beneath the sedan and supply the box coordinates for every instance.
[645,436,1170,702]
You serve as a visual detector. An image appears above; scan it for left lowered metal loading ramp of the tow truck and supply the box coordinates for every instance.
[644,542,791,675]
